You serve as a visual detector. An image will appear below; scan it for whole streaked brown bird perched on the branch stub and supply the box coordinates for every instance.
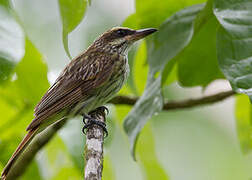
[1,27,157,180]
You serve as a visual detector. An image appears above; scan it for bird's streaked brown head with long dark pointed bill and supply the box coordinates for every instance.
[94,27,157,54]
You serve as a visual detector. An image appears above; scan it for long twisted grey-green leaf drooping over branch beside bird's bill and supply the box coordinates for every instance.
[124,5,203,156]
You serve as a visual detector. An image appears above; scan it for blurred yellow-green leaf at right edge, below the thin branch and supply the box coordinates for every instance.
[235,95,252,153]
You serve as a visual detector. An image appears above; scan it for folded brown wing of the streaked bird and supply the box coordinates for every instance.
[27,54,114,130]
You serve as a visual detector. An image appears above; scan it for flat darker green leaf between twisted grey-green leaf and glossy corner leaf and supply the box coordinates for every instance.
[176,0,223,86]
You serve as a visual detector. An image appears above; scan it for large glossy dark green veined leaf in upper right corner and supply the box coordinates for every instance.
[214,0,252,98]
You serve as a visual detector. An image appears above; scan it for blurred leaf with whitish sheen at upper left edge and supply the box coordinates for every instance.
[0,6,24,84]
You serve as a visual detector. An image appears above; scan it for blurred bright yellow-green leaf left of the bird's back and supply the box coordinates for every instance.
[16,40,49,105]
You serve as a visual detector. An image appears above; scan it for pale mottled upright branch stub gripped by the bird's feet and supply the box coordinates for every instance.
[84,112,106,180]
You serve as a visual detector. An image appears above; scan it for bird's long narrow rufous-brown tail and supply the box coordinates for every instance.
[1,127,38,180]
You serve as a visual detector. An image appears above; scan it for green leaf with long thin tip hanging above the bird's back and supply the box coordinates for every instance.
[58,0,87,59]
